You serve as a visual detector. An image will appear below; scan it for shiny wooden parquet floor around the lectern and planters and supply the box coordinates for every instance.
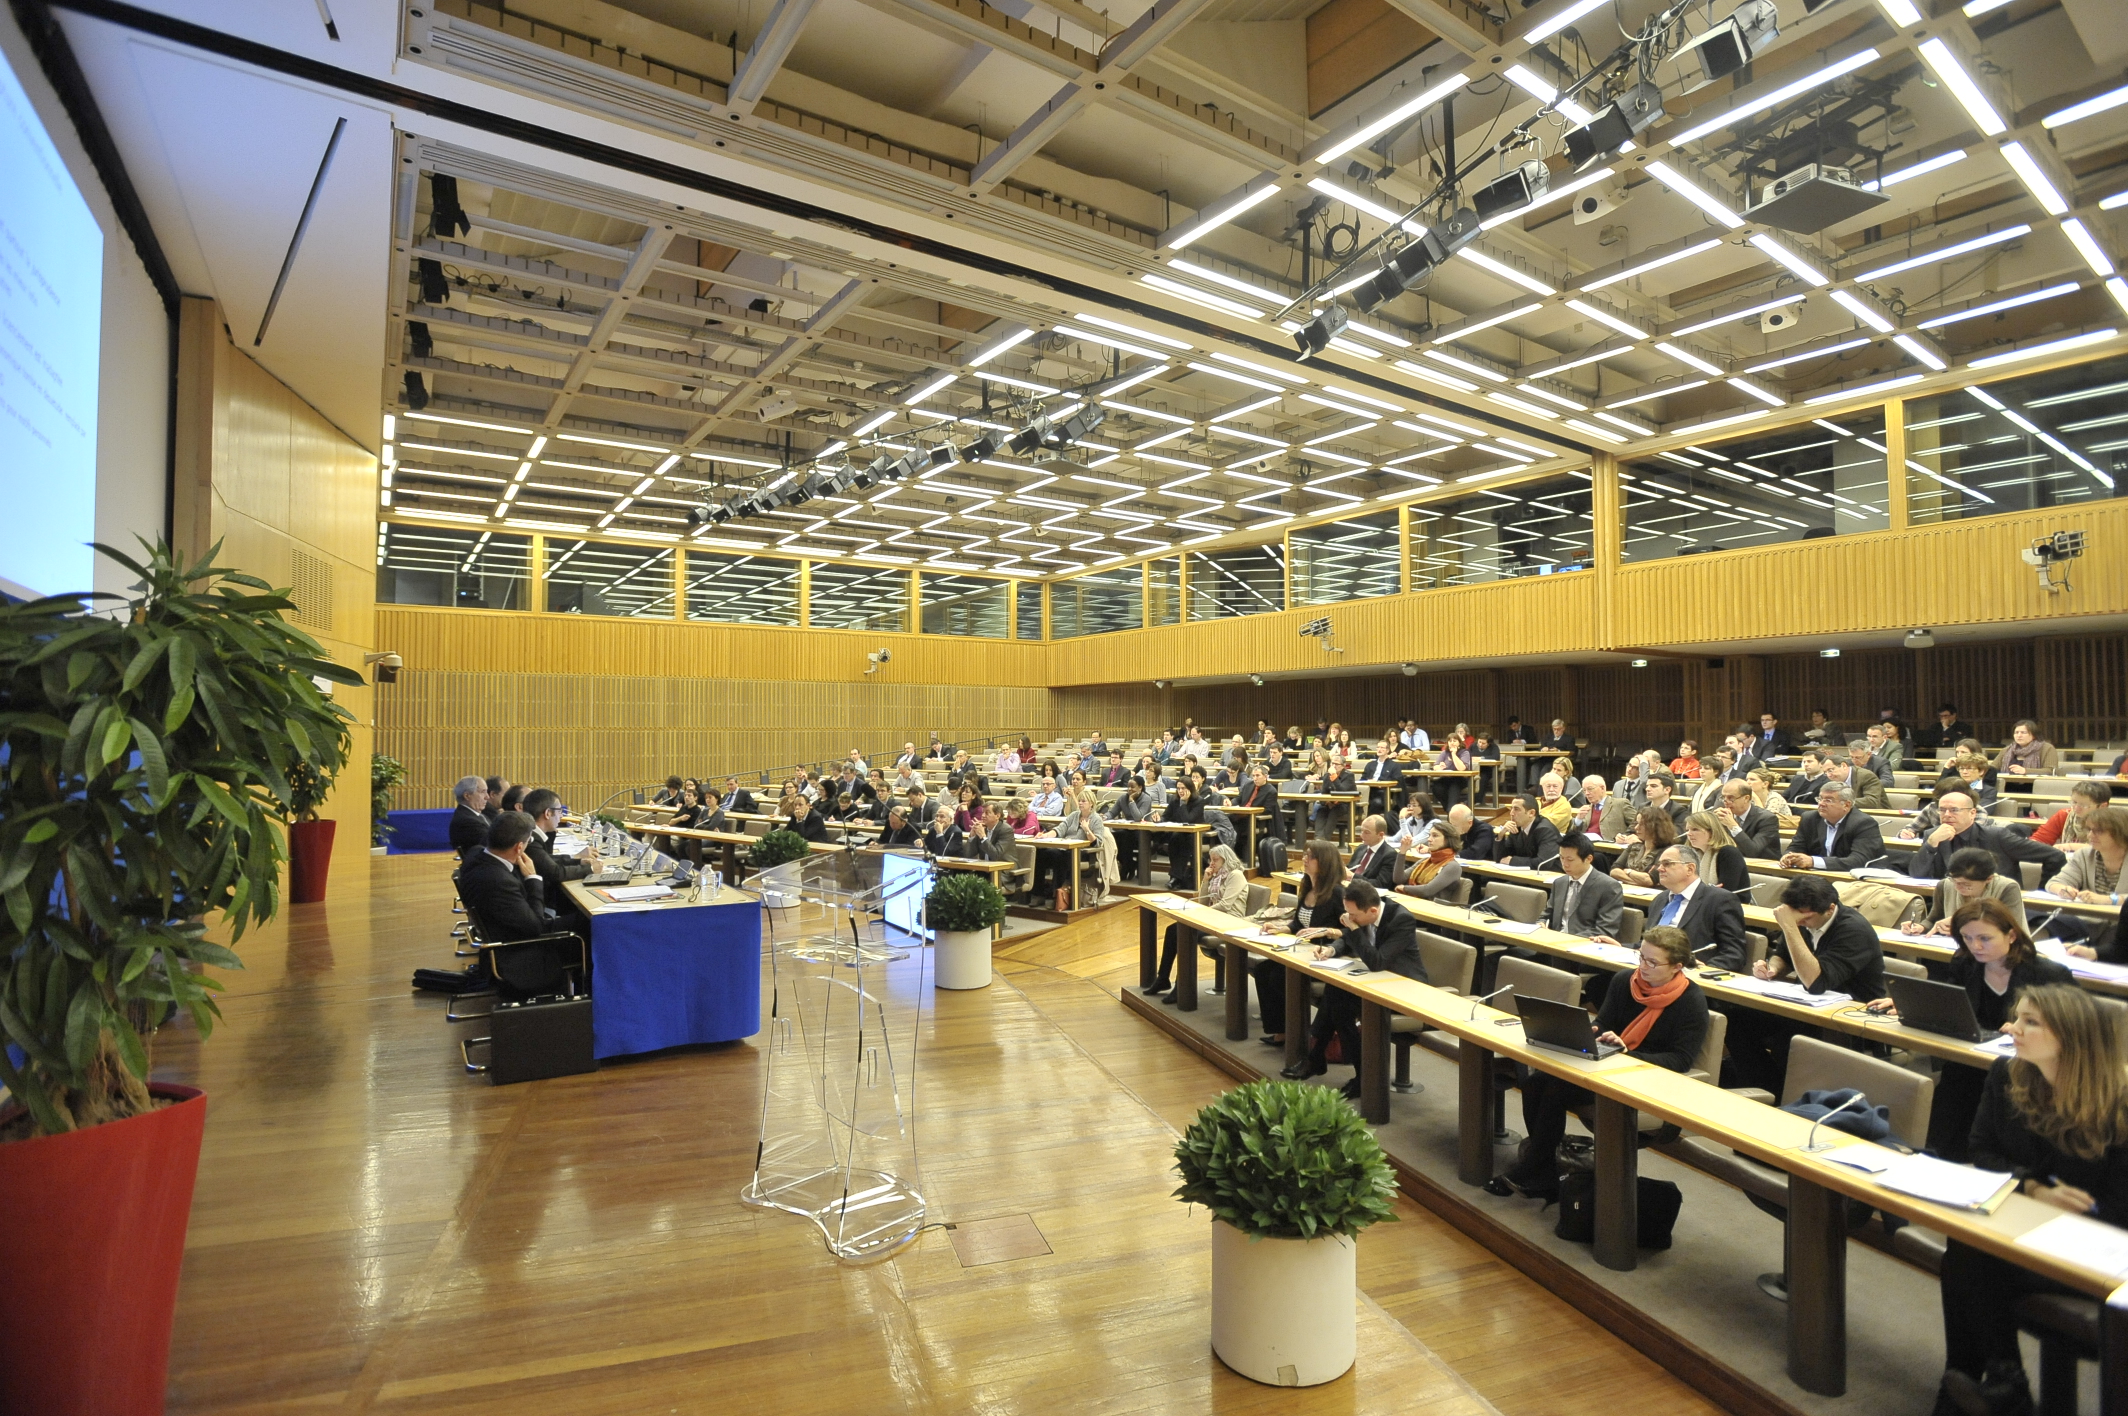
[155,856,1713,1416]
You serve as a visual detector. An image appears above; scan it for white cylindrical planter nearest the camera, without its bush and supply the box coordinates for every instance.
[1211,1220,1360,1386]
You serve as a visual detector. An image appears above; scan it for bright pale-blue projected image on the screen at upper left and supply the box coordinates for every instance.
[0,49,104,596]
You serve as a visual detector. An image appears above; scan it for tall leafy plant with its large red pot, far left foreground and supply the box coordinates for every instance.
[0,545,360,1416]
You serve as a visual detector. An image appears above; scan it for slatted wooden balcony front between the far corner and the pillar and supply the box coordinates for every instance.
[1049,571,1596,685]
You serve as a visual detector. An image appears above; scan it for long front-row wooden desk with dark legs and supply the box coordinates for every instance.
[1136,894,2128,1410]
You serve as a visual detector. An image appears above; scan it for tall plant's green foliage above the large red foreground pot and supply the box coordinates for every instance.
[0,545,362,1135]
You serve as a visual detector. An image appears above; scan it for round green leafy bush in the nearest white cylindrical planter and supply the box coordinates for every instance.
[1175,1082,1396,1239]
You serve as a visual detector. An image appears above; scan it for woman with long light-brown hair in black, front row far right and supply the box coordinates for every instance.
[1936,984,2128,1416]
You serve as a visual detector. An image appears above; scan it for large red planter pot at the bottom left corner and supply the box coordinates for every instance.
[0,1084,206,1416]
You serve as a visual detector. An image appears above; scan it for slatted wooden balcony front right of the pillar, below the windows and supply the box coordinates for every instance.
[1615,503,2128,647]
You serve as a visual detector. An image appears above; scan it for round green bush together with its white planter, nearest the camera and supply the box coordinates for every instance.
[1175,1082,1396,1386]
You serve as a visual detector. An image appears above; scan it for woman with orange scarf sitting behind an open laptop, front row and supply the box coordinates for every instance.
[1485,924,1707,1199]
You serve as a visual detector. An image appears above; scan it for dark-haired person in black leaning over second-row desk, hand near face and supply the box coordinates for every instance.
[1724,875,1883,1094]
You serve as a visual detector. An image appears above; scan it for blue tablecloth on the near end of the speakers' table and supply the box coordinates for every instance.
[592,896,762,1058]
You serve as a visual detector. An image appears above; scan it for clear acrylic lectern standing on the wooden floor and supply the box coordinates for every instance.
[738,850,932,1258]
